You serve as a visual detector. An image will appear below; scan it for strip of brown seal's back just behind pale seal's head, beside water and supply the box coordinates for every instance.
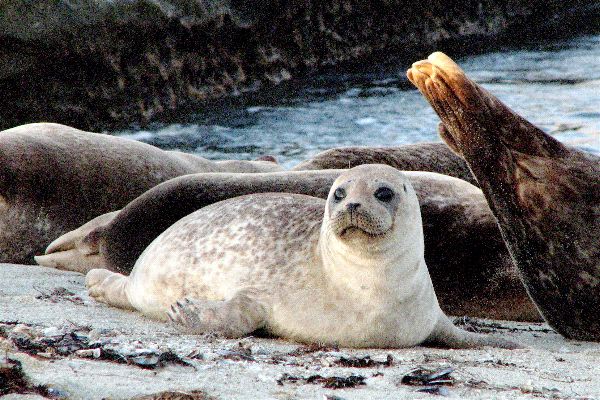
[292,142,478,186]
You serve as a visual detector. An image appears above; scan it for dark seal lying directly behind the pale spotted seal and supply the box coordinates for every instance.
[36,170,540,321]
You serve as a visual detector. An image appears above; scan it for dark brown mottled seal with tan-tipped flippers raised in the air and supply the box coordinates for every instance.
[407,52,600,341]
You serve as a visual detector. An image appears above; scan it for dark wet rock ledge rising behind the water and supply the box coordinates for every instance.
[0,0,599,129]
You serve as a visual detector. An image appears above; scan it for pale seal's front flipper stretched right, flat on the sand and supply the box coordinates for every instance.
[423,315,523,350]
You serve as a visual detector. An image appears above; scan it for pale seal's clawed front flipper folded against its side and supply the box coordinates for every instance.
[167,290,266,338]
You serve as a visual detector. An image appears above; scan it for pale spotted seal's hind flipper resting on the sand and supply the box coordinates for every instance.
[85,269,134,310]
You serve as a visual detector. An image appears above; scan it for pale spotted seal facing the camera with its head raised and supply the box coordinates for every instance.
[86,165,517,348]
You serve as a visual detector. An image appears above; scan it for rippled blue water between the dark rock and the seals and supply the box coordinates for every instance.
[114,34,600,167]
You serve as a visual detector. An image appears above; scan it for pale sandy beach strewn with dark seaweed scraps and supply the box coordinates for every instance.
[0,264,600,399]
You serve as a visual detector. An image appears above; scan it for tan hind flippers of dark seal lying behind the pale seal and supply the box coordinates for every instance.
[34,211,119,274]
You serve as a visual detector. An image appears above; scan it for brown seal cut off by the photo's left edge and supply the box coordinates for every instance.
[0,123,282,264]
